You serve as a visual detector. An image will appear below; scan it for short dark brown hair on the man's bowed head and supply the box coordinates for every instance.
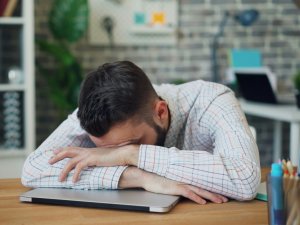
[77,61,158,137]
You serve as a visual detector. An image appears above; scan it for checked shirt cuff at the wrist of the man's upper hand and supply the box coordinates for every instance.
[138,145,170,176]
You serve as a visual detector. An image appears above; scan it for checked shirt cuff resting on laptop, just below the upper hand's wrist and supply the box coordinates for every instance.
[90,166,127,189]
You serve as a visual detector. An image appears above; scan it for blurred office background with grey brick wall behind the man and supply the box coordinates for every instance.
[0,0,300,177]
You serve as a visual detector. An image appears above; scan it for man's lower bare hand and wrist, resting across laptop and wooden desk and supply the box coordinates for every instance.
[119,167,228,204]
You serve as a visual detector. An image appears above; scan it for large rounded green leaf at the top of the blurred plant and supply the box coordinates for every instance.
[49,0,89,42]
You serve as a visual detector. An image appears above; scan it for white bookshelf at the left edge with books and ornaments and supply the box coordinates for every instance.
[0,0,35,178]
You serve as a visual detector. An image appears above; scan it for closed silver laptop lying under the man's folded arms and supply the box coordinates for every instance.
[20,188,180,213]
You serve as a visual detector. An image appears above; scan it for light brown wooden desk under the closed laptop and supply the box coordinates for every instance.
[0,169,268,225]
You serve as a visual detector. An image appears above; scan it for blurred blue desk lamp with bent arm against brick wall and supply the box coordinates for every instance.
[211,9,259,82]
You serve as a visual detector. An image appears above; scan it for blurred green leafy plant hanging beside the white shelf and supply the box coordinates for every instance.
[36,0,89,114]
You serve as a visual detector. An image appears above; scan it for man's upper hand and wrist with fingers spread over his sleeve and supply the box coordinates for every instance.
[49,145,139,182]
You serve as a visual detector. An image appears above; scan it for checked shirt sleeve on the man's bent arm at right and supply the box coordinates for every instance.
[137,92,261,200]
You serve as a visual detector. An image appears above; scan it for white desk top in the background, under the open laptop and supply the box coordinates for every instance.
[239,99,300,122]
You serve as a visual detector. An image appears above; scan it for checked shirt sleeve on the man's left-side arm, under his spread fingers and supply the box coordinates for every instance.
[21,111,126,189]
